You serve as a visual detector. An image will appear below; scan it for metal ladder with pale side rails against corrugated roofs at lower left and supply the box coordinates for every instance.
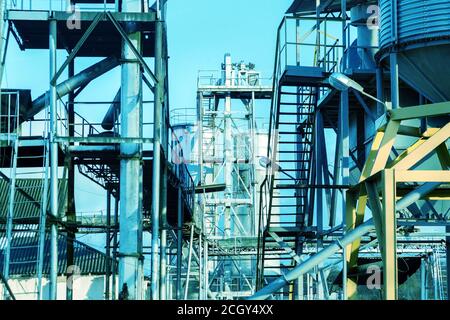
[3,135,49,300]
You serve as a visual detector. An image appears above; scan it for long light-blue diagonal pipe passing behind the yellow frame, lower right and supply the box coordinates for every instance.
[247,182,441,300]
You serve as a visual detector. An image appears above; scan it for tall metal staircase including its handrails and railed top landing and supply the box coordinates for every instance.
[257,18,339,299]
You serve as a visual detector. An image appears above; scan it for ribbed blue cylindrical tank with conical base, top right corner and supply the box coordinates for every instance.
[379,0,450,102]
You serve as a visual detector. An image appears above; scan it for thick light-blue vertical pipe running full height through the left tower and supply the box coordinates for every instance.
[119,0,143,300]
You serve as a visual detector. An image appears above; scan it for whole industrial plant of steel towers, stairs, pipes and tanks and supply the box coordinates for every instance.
[0,0,450,300]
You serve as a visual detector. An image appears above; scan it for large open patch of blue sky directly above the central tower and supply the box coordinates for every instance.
[167,0,292,108]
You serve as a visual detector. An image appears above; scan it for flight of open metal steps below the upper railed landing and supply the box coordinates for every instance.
[260,80,317,298]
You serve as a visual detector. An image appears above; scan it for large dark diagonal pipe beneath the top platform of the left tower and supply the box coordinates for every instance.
[23,57,120,120]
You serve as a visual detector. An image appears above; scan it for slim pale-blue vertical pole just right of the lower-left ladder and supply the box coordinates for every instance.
[49,18,59,300]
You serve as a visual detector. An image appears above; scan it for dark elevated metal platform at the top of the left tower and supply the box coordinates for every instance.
[7,9,156,57]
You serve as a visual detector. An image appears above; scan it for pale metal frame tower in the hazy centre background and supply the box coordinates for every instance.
[195,54,272,299]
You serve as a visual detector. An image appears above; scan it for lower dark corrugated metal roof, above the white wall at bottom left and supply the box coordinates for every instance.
[0,231,116,276]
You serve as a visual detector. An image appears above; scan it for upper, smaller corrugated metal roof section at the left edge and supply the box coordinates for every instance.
[0,179,67,221]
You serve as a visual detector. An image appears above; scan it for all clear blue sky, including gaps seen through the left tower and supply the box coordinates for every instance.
[3,0,292,255]
